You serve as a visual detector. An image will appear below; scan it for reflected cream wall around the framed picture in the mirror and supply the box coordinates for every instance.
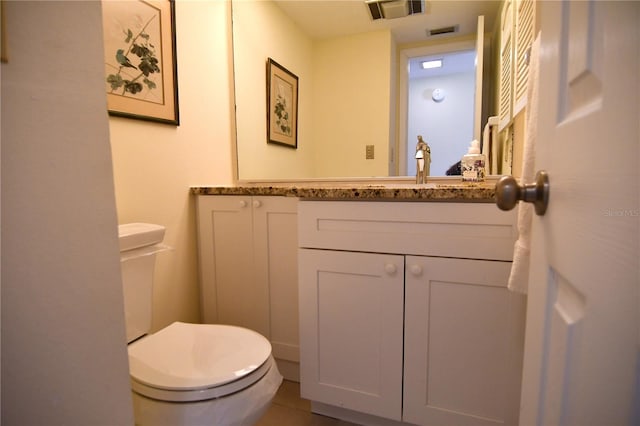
[233,1,315,180]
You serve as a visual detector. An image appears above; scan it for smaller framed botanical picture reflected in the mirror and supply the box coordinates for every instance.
[267,58,298,149]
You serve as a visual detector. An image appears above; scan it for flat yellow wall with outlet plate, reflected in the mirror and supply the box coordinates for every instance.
[313,31,395,177]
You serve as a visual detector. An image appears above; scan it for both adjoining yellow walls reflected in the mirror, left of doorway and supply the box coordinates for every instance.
[233,1,395,180]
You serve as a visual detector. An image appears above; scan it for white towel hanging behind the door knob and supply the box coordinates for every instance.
[509,34,540,294]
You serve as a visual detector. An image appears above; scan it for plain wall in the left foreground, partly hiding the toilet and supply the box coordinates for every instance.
[2,1,133,426]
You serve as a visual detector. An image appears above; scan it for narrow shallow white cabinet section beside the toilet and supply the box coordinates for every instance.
[197,195,299,380]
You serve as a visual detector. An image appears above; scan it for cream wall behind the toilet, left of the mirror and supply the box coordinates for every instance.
[109,0,233,330]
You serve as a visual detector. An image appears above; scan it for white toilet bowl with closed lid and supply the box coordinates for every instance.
[129,322,282,426]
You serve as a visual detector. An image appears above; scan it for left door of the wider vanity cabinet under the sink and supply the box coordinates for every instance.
[298,249,404,420]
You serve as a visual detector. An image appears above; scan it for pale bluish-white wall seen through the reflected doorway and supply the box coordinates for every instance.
[407,71,475,176]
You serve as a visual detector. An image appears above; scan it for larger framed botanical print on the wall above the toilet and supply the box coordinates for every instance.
[102,0,180,125]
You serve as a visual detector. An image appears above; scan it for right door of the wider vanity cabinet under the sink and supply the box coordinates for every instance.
[403,256,524,425]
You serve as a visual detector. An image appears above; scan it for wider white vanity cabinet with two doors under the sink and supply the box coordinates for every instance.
[298,201,525,425]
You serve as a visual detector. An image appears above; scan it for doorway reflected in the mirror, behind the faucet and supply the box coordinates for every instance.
[396,16,486,176]
